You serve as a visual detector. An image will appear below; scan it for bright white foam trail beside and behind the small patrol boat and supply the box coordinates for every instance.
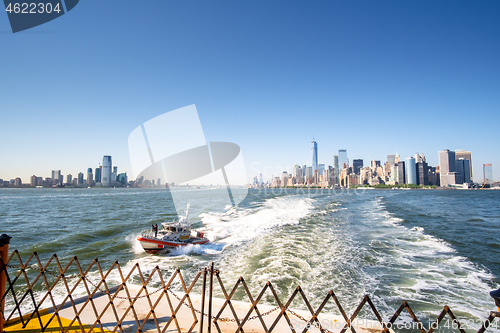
[116,196,314,288]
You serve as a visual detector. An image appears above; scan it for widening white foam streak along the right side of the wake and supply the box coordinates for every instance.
[365,197,494,324]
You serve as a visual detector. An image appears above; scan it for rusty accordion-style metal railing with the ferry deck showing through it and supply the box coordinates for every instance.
[0,250,500,333]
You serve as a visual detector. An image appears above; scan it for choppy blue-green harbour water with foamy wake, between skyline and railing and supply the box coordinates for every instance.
[0,188,500,326]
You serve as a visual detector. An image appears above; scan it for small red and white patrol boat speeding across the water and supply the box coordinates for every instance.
[137,205,209,253]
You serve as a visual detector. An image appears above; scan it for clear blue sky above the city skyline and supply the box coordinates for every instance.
[0,0,500,182]
